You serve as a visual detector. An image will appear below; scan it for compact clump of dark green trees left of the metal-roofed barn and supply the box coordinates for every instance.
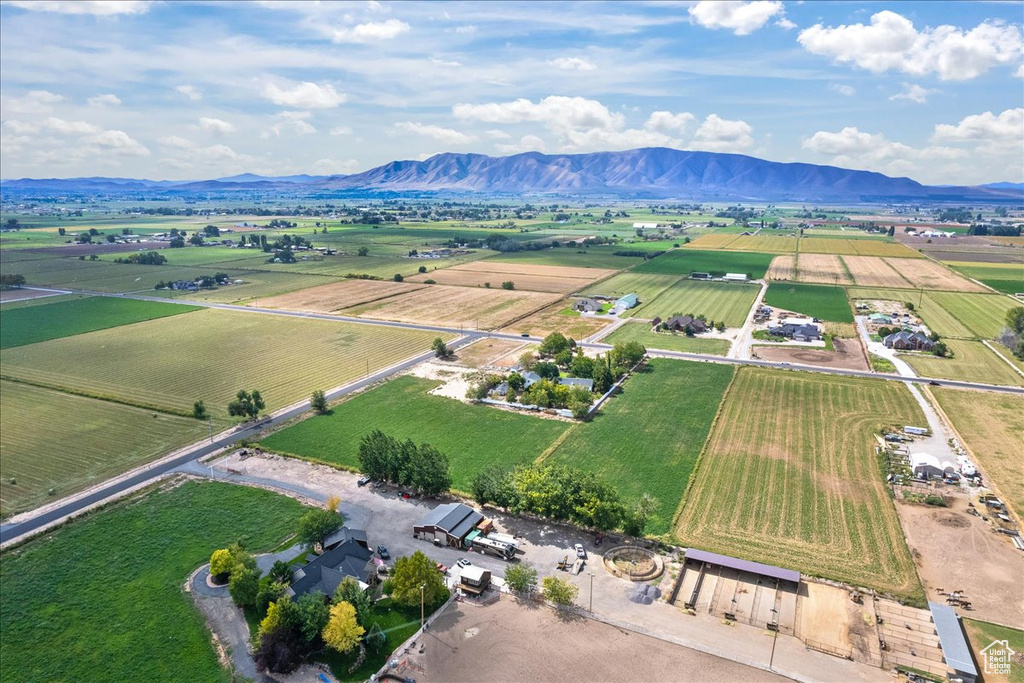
[359,429,452,496]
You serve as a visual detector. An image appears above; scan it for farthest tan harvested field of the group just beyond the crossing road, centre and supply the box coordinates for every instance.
[408,261,614,293]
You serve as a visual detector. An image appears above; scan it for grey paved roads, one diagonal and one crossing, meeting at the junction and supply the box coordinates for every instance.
[0,290,1024,543]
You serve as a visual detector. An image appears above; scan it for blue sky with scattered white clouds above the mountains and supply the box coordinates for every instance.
[0,0,1024,184]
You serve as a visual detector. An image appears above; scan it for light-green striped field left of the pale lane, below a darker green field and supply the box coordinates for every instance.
[630,279,760,328]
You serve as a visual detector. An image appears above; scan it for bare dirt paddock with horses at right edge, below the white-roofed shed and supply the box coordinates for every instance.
[896,496,1024,624]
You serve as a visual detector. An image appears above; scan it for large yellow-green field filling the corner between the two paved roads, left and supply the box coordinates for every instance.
[0,309,451,419]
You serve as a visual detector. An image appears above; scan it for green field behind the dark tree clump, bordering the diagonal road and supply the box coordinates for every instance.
[263,376,567,492]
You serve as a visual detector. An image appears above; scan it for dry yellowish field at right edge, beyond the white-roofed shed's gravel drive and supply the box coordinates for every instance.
[930,387,1024,516]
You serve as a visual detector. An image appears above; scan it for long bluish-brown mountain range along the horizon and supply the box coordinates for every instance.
[0,147,1024,202]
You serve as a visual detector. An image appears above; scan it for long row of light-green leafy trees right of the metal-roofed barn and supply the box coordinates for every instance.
[472,464,657,536]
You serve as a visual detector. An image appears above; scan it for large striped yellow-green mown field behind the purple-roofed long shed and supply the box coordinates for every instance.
[675,368,924,600]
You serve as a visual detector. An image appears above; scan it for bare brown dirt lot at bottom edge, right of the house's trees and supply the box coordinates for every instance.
[401,596,785,683]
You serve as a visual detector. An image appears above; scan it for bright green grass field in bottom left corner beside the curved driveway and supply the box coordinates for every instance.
[0,482,302,682]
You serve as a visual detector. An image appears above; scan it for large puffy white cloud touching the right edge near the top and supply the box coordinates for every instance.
[797,10,1024,81]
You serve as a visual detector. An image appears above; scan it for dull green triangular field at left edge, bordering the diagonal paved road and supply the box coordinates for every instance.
[0,382,210,516]
